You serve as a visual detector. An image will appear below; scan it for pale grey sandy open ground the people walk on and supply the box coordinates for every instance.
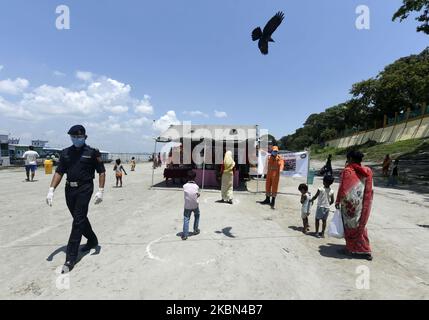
[0,164,429,299]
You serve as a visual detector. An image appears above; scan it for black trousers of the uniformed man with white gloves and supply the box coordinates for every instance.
[66,182,97,262]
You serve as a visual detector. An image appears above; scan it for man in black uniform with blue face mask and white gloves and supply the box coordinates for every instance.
[46,125,106,273]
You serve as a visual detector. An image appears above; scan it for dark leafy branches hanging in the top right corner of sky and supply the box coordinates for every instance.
[392,0,429,34]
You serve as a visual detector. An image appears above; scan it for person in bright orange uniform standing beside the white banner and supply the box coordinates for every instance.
[261,146,284,209]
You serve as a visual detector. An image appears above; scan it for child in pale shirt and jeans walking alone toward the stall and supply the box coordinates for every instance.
[182,170,200,240]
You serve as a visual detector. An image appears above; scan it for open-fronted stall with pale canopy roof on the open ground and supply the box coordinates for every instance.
[152,124,259,187]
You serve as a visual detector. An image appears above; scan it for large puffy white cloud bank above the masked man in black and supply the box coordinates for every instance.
[0,74,166,152]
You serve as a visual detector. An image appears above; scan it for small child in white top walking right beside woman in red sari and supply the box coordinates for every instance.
[311,175,335,238]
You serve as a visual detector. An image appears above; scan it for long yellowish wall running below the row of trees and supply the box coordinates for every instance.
[327,116,429,148]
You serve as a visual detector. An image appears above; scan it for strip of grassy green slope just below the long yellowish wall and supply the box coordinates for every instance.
[310,139,429,162]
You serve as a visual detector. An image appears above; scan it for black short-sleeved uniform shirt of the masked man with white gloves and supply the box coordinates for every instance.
[56,145,106,182]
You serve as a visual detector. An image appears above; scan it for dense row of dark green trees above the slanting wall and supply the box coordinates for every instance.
[278,47,429,151]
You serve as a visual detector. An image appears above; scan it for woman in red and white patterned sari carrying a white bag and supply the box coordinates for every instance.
[335,151,373,260]
